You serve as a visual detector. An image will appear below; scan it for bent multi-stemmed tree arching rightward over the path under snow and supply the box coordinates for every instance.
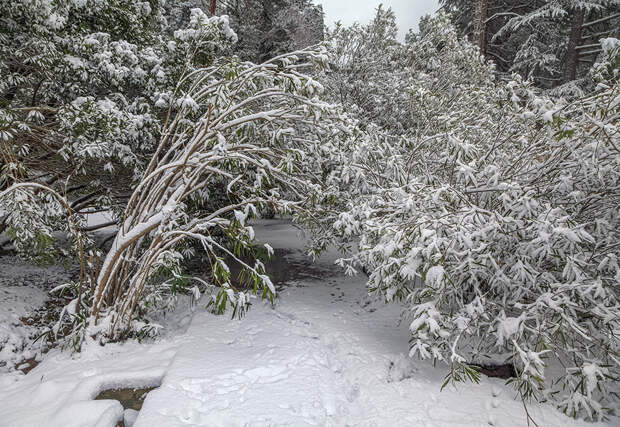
[90,49,358,337]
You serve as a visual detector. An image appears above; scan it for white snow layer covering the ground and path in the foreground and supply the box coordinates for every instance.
[0,221,612,427]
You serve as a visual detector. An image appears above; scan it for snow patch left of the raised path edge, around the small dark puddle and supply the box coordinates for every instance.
[0,340,178,427]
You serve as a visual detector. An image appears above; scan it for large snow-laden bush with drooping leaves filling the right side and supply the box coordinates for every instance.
[334,12,620,419]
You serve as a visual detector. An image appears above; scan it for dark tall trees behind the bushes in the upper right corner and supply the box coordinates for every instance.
[440,0,620,88]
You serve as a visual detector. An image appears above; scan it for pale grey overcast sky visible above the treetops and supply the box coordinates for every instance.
[314,0,439,39]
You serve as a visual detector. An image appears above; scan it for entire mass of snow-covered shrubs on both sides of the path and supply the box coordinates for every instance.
[0,0,620,419]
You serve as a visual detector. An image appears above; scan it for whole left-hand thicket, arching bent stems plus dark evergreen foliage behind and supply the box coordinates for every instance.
[0,0,355,345]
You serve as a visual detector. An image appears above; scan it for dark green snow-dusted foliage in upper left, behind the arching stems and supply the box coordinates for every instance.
[0,0,236,256]
